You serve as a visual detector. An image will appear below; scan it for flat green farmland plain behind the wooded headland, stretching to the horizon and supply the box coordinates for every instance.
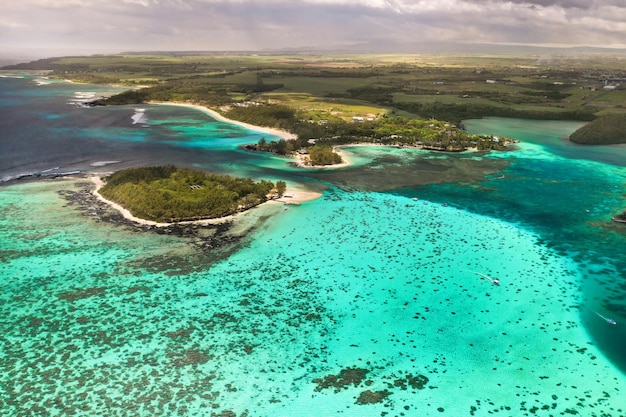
[8,52,626,121]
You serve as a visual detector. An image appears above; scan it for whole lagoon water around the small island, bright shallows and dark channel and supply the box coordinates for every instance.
[0,73,626,417]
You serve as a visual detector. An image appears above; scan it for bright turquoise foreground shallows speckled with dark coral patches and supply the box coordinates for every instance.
[0,183,625,416]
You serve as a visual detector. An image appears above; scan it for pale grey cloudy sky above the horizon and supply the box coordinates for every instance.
[0,0,626,54]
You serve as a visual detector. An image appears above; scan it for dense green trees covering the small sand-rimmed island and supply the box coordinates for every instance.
[99,165,286,223]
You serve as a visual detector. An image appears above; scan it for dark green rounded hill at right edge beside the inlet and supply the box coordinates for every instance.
[569,114,626,145]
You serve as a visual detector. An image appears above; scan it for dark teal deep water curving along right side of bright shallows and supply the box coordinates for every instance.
[395,176,626,373]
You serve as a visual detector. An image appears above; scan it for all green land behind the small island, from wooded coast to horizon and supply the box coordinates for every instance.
[6,52,626,148]
